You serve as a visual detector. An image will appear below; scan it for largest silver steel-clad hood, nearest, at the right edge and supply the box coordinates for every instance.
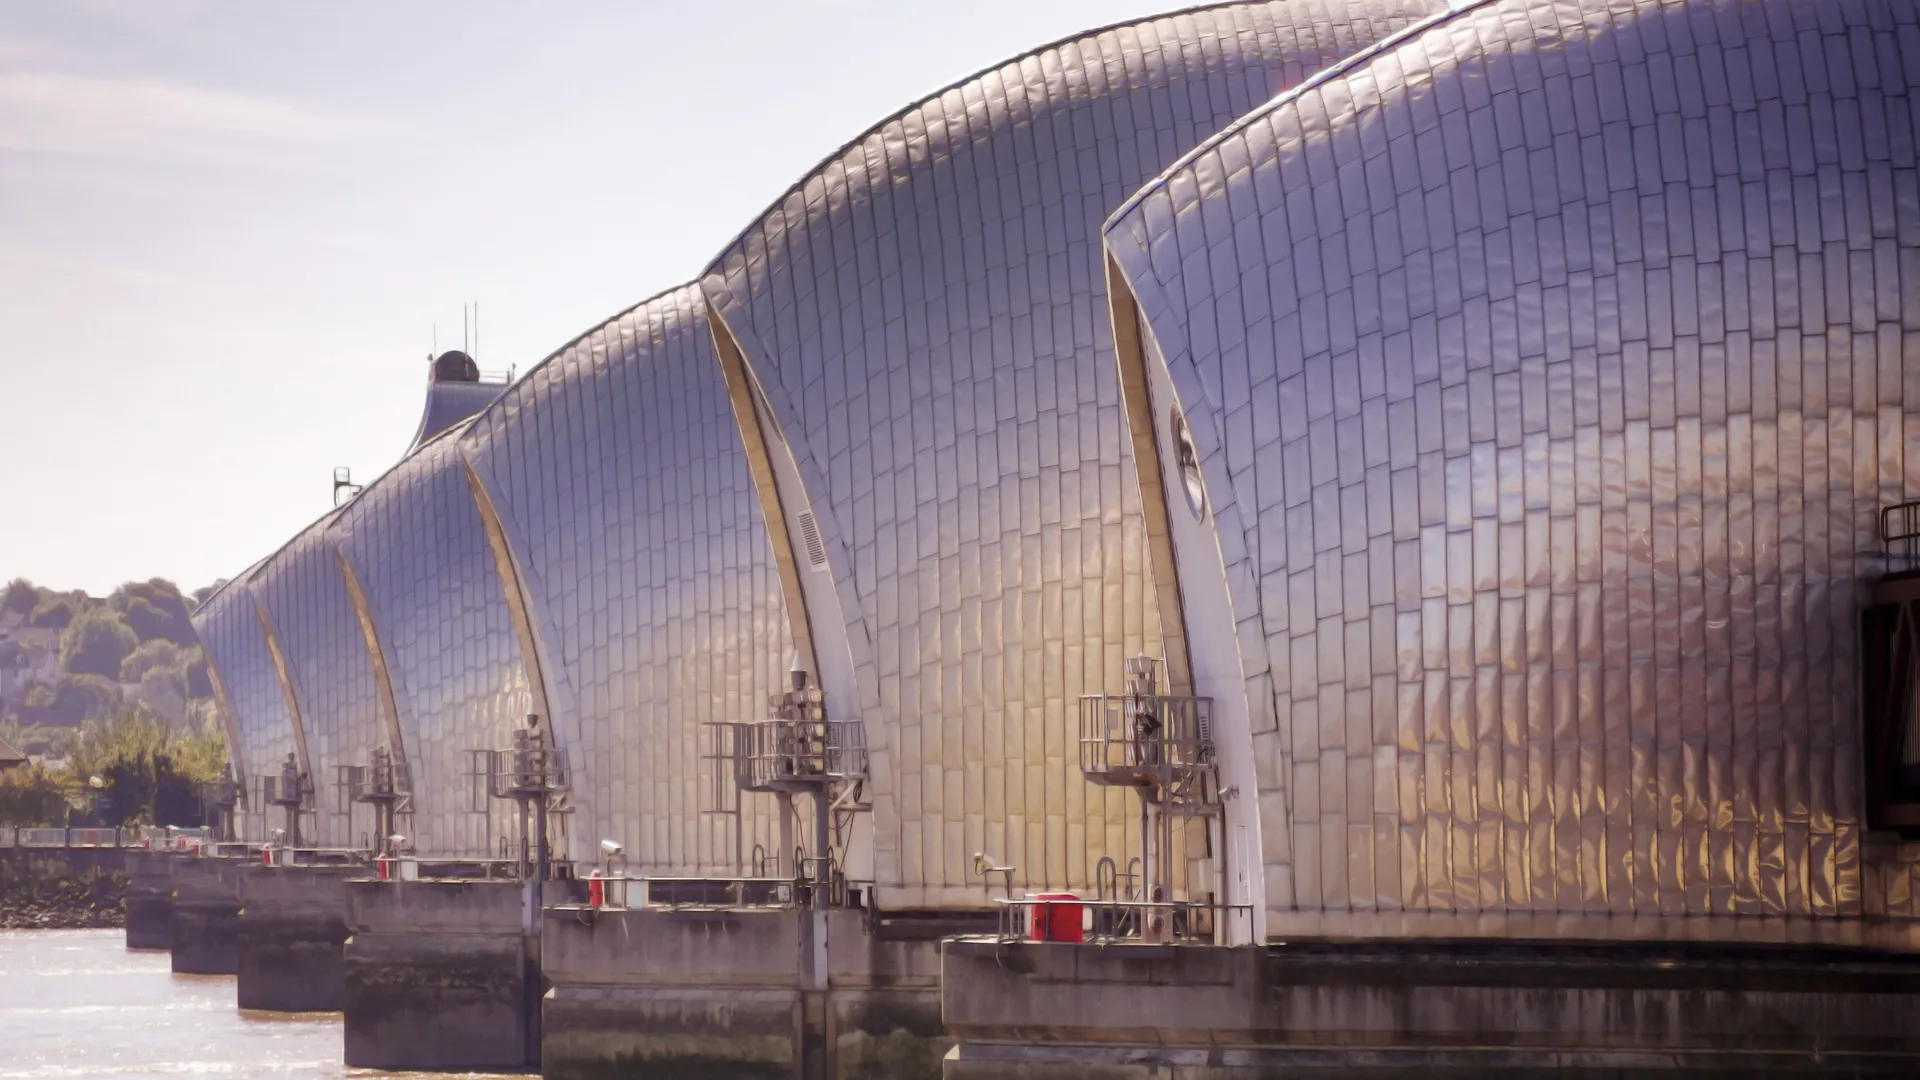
[1106,0,1920,917]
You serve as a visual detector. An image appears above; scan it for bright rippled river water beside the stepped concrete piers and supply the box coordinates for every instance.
[0,930,518,1080]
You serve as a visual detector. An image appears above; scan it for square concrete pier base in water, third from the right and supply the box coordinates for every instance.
[342,880,543,1072]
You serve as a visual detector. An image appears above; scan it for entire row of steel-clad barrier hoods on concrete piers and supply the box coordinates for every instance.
[139,0,1920,1080]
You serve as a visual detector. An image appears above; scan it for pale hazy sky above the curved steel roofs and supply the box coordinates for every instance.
[0,0,1152,594]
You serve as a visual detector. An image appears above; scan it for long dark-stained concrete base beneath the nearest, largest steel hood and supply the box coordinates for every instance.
[941,940,1920,1080]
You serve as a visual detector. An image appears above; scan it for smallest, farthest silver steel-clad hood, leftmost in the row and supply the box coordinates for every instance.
[194,567,294,840]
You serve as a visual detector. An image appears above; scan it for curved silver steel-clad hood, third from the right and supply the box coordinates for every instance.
[463,286,793,876]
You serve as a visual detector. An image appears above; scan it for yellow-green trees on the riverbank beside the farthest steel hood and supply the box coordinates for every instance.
[67,709,227,826]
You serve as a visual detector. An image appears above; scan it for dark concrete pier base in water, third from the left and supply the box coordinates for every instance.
[238,865,367,1013]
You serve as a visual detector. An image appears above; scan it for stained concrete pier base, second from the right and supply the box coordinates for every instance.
[540,907,952,1080]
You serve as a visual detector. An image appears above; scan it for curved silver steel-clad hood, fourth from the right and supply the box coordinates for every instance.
[332,429,536,855]
